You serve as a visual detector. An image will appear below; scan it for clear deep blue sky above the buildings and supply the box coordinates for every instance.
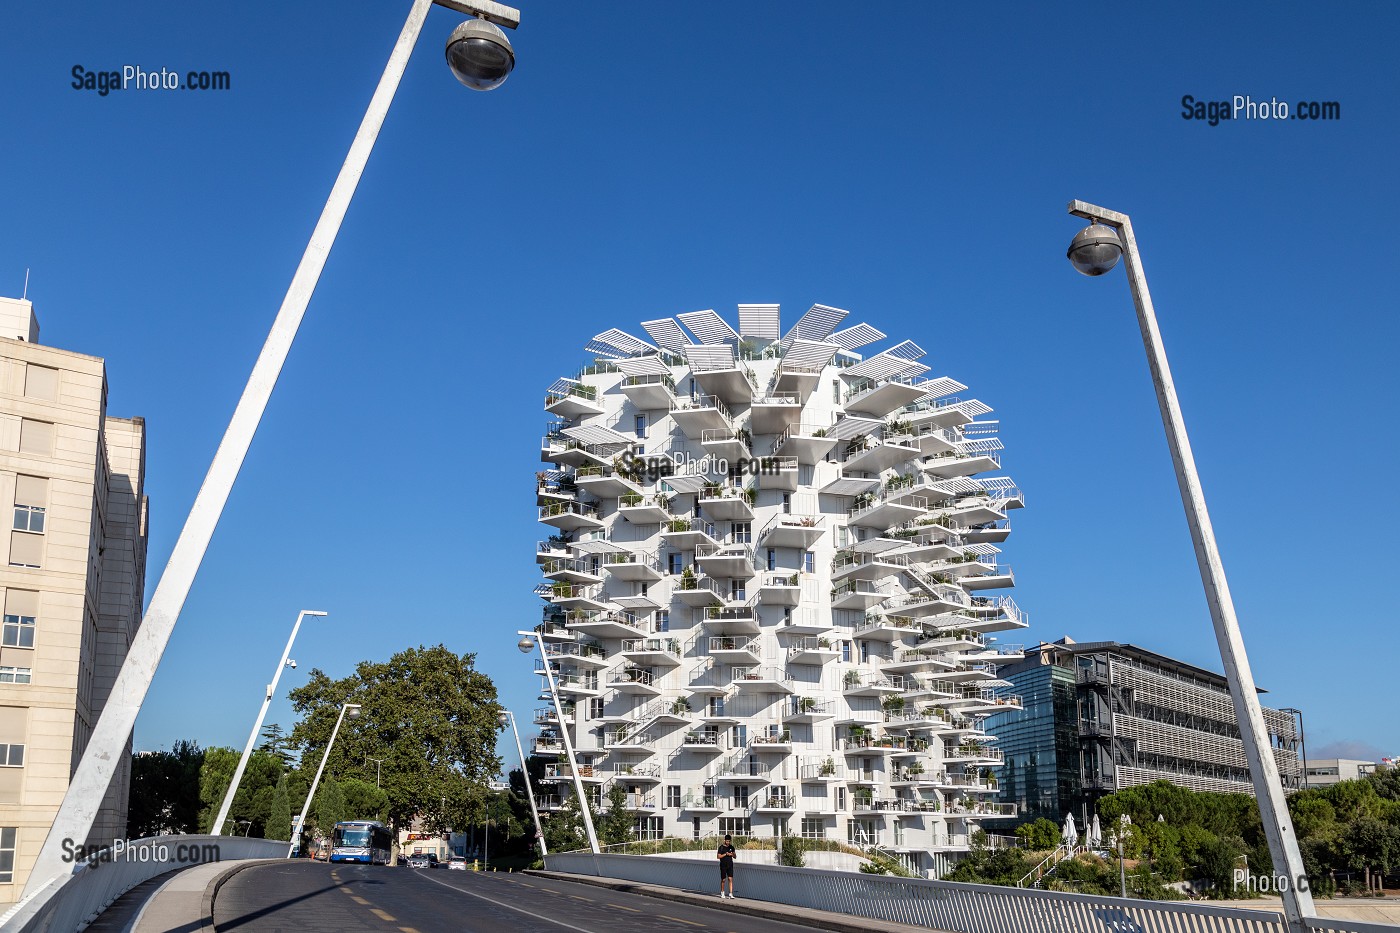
[0,0,1400,755]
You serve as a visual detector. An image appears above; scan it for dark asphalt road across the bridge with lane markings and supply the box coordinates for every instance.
[214,859,834,933]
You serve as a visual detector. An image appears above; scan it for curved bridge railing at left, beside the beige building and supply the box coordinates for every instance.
[0,835,287,933]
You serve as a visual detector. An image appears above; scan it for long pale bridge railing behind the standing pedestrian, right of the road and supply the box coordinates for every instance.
[545,850,1400,933]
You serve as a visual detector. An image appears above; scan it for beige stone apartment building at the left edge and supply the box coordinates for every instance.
[0,298,147,905]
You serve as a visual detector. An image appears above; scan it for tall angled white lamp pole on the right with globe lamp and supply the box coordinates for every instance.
[1068,200,1316,933]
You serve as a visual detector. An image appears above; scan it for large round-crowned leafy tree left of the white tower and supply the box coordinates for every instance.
[291,644,501,831]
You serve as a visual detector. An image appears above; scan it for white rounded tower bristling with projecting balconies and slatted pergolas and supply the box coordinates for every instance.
[533,305,1025,874]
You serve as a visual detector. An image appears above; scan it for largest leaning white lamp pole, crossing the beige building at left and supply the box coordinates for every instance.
[24,0,519,895]
